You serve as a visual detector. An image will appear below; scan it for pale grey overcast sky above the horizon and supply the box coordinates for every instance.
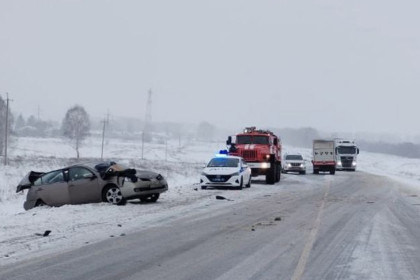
[0,0,420,134]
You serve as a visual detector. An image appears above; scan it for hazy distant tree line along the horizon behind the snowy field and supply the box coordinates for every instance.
[0,96,420,158]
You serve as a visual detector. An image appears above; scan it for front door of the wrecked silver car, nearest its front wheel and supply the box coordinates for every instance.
[68,166,102,204]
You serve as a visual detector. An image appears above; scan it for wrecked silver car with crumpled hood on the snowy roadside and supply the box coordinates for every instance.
[16,162,168,210]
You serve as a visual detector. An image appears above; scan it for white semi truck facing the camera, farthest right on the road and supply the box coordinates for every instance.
[335,139,359,171]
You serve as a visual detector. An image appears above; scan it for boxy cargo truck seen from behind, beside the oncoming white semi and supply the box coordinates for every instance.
[312,139,336,175]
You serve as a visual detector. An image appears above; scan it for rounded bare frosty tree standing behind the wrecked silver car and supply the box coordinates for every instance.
[62,105,90,158]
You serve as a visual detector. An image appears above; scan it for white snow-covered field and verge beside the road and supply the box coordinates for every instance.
[0,138,420,265]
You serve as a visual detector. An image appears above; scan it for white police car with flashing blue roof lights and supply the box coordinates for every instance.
[200,152,251,189]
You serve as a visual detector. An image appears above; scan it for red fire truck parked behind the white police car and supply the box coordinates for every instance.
[226,127,282,184]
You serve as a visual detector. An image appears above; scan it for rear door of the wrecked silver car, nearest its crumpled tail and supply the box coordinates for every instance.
[34,170,70,206]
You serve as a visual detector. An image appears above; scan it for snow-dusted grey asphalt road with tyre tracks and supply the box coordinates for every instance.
[0,172,420,280]
